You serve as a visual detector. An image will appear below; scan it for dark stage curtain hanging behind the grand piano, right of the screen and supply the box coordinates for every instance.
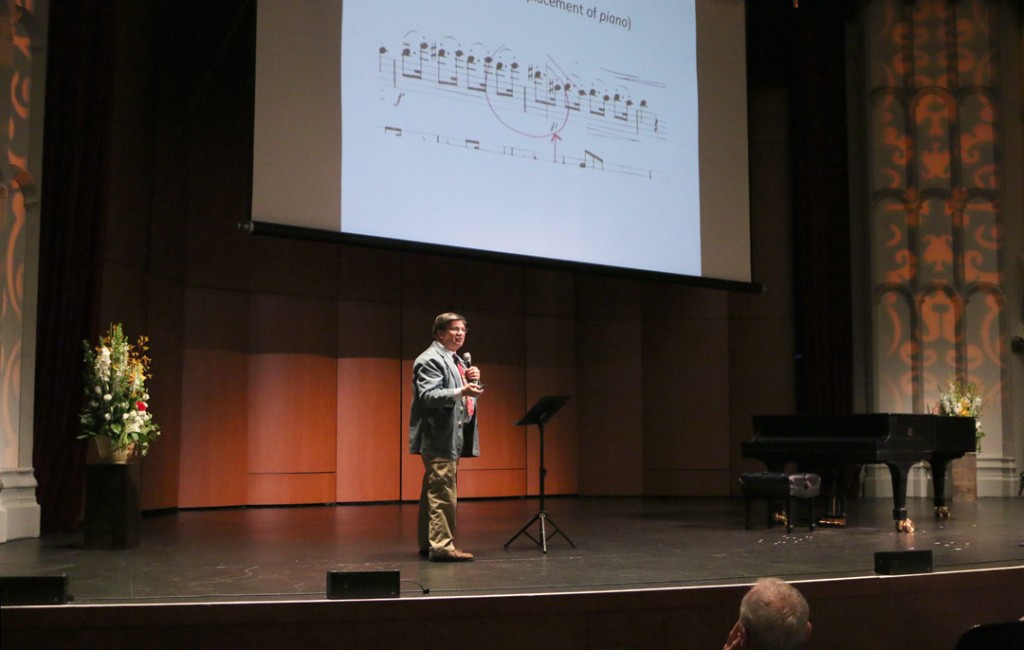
[745,0,857,414]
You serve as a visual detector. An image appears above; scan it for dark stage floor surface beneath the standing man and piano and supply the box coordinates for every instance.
[0,496,1024,604]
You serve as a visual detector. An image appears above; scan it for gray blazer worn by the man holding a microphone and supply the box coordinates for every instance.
[409,341,480,461]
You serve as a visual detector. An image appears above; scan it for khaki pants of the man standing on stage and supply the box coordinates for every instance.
[417,456,459,555]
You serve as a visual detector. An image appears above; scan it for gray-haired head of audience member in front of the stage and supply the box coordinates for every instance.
[723,577,811,650]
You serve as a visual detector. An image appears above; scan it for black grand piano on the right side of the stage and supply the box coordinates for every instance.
[741,414,976,532]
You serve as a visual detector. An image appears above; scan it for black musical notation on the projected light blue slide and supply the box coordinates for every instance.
[377,32,671,178]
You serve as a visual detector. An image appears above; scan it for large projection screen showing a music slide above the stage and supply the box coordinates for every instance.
[252,0,751,287]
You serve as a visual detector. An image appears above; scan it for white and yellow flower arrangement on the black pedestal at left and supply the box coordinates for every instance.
[79,323,160,456]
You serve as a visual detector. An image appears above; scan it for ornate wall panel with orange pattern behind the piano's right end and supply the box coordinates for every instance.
[865,0,1007,451]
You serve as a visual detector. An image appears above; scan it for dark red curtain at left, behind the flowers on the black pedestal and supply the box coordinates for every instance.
[33,0,114,533]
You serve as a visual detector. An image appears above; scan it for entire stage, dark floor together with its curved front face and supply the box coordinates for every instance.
[0,497,1024,650]
